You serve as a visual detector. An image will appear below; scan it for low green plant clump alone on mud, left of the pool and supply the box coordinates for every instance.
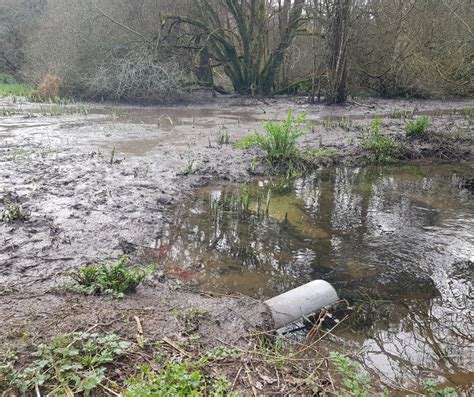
[64,256,155,298]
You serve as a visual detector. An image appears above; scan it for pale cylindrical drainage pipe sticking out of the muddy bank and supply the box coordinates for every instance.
[265,280,339,329]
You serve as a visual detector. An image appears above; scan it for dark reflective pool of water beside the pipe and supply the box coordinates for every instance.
[155,164,474,386]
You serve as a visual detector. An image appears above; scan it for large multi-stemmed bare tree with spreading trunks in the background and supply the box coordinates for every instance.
[167,0,305,95]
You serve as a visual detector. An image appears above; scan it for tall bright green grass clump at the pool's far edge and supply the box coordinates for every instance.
[236,110,308,165]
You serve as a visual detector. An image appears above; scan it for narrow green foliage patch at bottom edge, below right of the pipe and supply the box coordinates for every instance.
[330,352,372,397]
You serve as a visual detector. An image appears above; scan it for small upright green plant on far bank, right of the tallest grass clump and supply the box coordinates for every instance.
[362,117,400,164]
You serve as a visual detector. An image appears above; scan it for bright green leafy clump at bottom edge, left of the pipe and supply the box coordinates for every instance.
[124,361,237,397]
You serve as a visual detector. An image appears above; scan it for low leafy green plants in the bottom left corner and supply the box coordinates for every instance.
[5,332,130,396]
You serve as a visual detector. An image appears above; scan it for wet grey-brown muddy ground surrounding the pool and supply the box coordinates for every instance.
[0,97,474,392]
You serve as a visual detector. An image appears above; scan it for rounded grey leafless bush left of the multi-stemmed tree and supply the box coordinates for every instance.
[90,46,192,101]
